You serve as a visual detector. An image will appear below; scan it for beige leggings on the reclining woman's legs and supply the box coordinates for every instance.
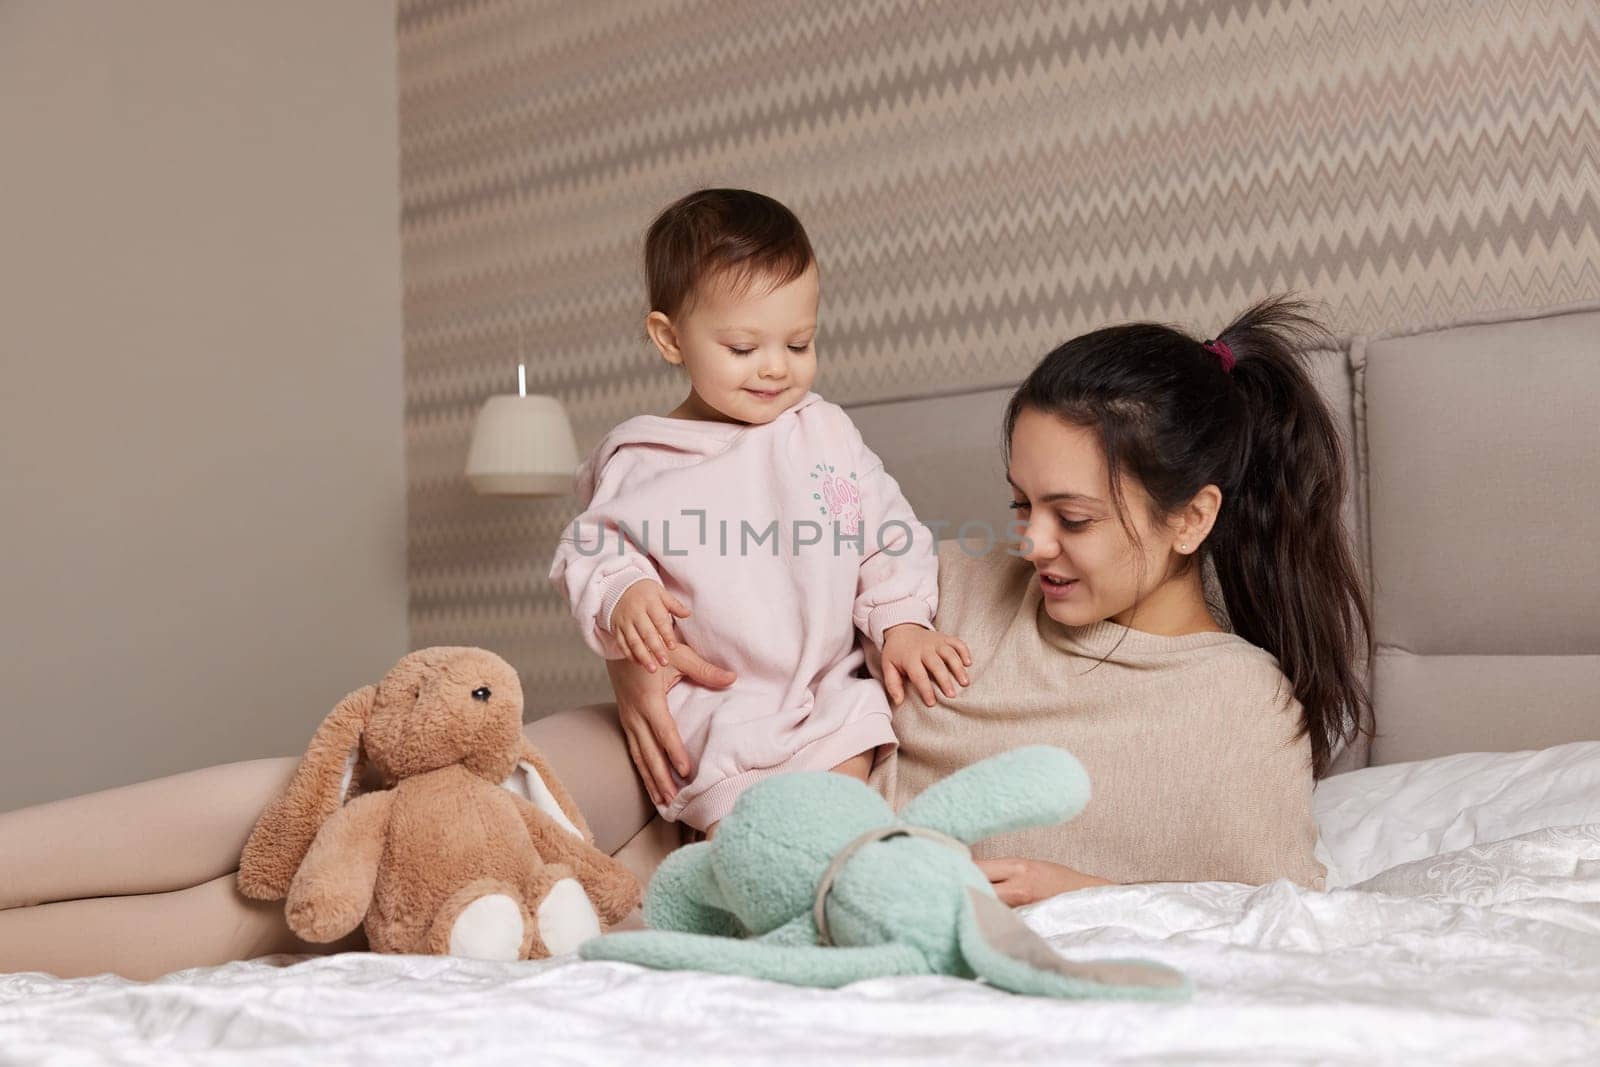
[0,704,656,979]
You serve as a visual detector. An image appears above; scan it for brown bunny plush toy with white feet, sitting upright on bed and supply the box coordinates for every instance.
[238,648,640,960]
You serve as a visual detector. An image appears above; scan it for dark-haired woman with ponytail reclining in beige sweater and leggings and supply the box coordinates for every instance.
[0,299,1370,977]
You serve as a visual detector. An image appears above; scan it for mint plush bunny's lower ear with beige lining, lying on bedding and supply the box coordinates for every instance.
[958,888,1192,1000]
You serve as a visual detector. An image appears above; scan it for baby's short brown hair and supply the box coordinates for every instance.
[645,189,816,318]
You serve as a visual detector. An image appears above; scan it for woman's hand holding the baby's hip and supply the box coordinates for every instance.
[605,639,738,808]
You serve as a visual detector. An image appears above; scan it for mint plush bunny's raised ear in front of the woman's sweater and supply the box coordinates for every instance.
[899,745,1090,845]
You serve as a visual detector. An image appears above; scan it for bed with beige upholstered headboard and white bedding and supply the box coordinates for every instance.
[0,307,1600,1064]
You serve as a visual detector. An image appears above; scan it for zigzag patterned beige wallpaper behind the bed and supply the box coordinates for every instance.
[398,0,1600,713]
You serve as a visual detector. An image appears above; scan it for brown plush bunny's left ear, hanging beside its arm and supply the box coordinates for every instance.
[238,685,378,901]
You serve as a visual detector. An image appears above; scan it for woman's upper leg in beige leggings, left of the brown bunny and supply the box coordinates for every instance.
[0,758,296,909]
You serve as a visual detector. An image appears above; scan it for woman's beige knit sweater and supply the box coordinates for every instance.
[872,542,1325,888]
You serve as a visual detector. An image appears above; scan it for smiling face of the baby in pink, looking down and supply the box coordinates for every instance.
[662,266,818,426]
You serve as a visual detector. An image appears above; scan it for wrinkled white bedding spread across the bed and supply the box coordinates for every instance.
[0,822,1600,1065]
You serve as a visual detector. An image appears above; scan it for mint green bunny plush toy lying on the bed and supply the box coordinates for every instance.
[579,745,1190,1000]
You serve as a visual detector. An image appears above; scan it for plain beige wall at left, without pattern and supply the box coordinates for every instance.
[0,0,406,809]
